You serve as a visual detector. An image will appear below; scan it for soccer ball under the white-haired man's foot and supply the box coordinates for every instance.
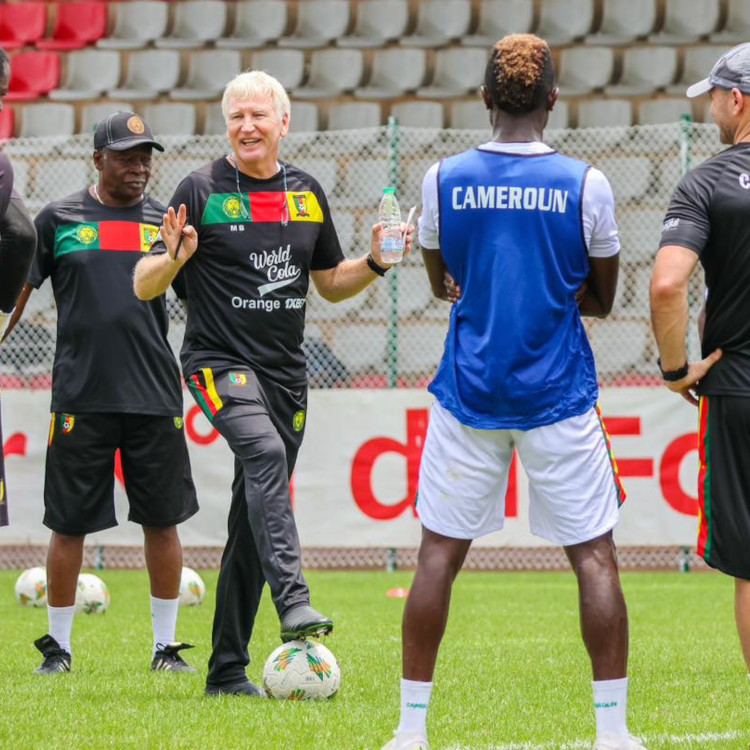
[263,641,341,701]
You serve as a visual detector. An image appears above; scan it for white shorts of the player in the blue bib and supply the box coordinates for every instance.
[417,402,625,546]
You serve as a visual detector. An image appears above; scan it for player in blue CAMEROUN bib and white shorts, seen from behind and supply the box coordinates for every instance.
[386,34,644,750]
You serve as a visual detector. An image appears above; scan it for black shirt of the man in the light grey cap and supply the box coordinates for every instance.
[660,143,750,396]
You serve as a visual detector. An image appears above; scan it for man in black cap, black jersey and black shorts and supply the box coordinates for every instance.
[5,112,198,674]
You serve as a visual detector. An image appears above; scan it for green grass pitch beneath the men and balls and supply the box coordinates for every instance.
[0,570,750,750]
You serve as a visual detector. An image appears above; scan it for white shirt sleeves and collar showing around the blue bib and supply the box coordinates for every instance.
[419,141,620,258]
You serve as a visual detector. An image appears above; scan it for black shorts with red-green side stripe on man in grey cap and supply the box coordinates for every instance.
[698,396,750,580]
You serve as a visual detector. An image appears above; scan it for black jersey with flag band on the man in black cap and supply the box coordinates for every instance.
[29,190,182,415]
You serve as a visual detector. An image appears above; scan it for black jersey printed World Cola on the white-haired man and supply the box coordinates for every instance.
[160,157,344,387]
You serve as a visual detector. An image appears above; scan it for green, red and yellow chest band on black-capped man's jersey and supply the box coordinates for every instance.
[54,221,159,258]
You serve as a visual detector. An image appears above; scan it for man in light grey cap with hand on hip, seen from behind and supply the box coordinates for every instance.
[651,44,750,676]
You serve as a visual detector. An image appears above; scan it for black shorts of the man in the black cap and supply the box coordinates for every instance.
[44,413,198,536]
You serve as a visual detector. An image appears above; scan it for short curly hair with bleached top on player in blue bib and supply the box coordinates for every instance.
[484,34,555,115]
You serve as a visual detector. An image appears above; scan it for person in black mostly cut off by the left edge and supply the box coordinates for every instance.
[0,49,36,526]
